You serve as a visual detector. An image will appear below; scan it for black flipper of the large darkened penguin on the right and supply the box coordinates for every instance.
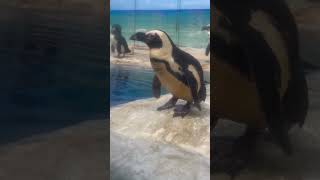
[240,27,292,154]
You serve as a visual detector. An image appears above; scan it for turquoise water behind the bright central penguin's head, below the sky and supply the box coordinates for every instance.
[110,9,210,48]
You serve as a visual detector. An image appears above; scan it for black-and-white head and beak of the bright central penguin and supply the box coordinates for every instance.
[130,30,175,58]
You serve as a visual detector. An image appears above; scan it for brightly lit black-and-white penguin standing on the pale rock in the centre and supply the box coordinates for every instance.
[130,30,206,117]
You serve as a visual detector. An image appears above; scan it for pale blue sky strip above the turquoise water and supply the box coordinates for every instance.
[110,0,210,10]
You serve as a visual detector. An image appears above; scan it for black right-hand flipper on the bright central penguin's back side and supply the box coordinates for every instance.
[184,69,201,111]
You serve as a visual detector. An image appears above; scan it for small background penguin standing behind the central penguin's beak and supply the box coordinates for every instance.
[110,24,131,57]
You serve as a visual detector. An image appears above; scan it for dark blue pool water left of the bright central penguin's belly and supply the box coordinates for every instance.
[110,65,166,106]
